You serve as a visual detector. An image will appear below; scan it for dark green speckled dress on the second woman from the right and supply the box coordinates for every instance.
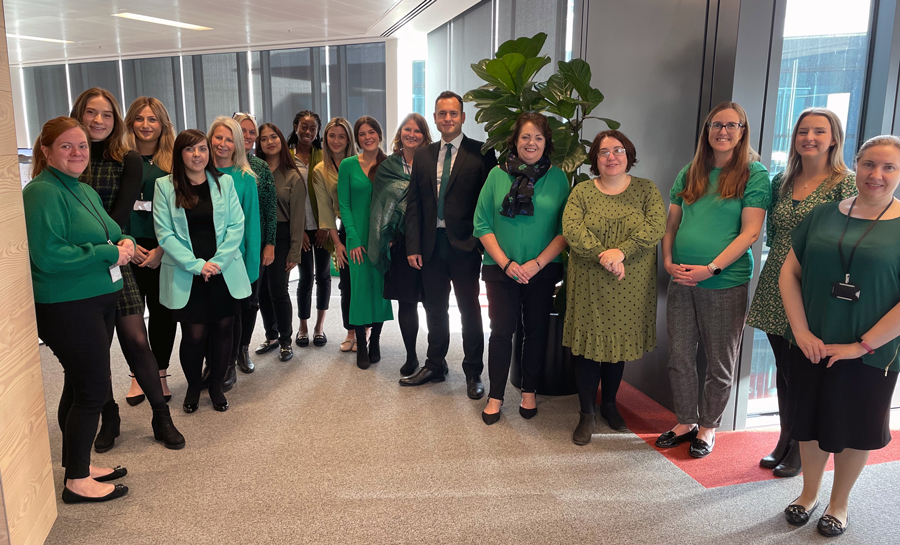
[747,172,857,335]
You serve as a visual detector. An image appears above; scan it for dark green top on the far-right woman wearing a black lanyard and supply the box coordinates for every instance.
[784,202,900,371]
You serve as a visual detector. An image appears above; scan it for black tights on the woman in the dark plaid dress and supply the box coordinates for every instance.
[115,314,166,409]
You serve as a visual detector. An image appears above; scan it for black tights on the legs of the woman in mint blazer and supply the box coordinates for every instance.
[178,316,234,404]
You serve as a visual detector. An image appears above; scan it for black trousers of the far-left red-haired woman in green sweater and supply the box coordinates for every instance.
[34,291,119,479]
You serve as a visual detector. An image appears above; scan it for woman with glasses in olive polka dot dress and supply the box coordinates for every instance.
[563,130,666,445]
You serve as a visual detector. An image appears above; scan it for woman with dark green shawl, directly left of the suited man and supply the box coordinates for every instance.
[368,113,431,377]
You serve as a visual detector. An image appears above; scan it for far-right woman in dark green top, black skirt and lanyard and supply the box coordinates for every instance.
[779,135,900,537]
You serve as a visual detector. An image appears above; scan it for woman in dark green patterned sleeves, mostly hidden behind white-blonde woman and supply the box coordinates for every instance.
[225,112,276,372]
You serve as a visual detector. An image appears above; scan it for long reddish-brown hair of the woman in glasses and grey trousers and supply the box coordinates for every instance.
[678,102,759,204]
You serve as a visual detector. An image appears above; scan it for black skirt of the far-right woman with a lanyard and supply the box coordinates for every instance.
[788,344,897,453]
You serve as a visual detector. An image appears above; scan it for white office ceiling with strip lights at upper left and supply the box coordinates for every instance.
[3,0,477,66]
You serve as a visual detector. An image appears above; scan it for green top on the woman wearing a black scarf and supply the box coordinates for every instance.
[473,167,569,265]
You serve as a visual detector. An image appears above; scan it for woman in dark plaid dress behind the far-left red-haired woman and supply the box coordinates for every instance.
[71,87,184,452]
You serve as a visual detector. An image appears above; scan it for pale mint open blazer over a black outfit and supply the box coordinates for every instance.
[153,173,250,309]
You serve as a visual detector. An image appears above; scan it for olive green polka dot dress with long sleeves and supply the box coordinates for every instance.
[563,177,666,362]
